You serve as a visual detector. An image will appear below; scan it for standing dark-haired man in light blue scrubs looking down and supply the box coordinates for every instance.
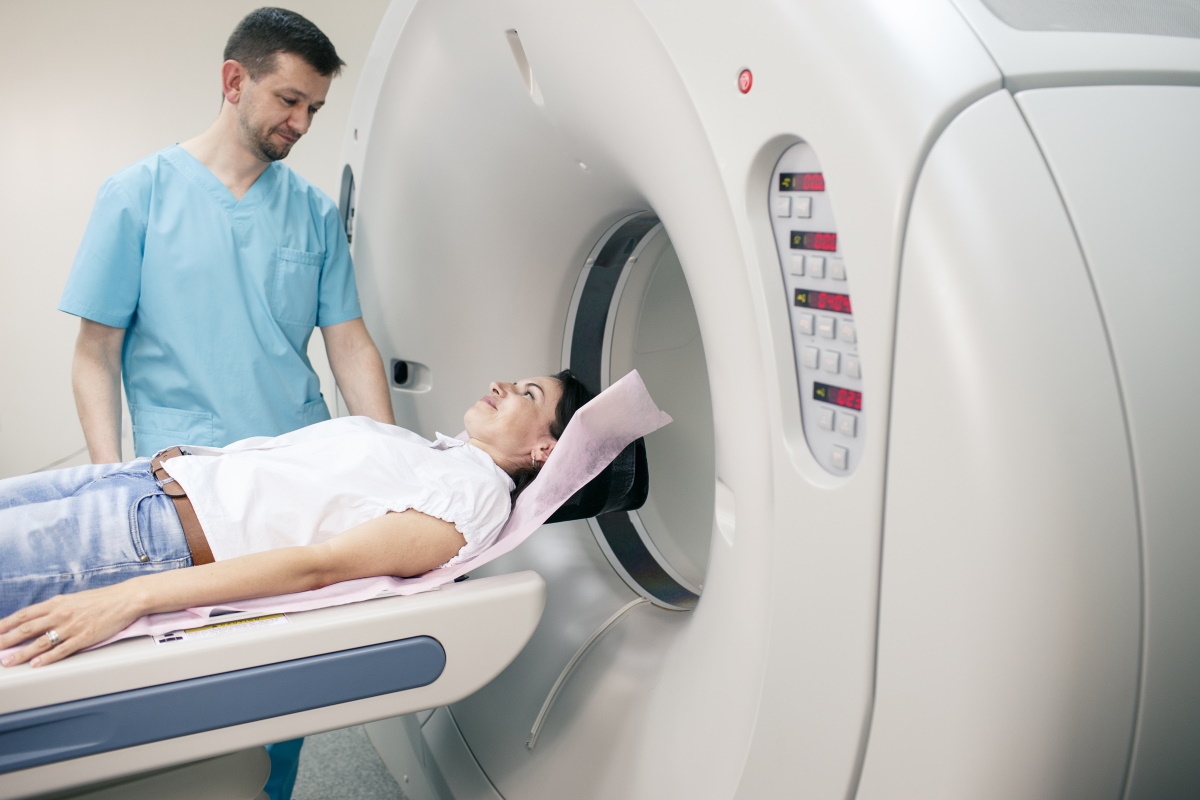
[59,8,395,800]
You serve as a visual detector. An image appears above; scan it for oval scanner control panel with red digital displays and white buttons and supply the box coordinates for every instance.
[768,142,866,475]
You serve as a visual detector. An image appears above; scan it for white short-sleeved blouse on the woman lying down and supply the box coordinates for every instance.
[164,416,514,566]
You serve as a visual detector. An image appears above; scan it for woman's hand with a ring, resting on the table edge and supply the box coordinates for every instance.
[0,583,142,667]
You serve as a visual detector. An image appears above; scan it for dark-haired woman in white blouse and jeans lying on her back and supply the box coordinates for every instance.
[0,371,592,667]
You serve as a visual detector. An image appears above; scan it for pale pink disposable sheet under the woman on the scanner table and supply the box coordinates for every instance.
[7,369,671,648]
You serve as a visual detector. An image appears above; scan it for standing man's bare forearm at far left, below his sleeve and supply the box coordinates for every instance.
[71,319,125,464]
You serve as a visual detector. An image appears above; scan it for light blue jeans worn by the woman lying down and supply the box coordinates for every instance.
[0,458,192,616]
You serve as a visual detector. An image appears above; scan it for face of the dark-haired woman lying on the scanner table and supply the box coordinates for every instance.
[463,378,563,467]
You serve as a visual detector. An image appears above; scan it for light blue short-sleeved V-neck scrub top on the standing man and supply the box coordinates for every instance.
[59,145,362,456]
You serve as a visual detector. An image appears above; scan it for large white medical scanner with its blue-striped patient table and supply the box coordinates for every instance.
[0,0,1200,800]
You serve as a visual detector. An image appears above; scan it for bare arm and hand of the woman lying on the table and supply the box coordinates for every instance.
[0,510,466,667]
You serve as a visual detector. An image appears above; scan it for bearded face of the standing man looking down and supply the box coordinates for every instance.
[238,53,332,162]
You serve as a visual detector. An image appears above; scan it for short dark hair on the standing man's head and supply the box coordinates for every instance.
[224,7,346,80]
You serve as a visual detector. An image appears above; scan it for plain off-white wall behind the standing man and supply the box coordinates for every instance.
[0,0,388,477]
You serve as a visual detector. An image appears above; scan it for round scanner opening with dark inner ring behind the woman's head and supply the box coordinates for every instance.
[564,212,715,609]
